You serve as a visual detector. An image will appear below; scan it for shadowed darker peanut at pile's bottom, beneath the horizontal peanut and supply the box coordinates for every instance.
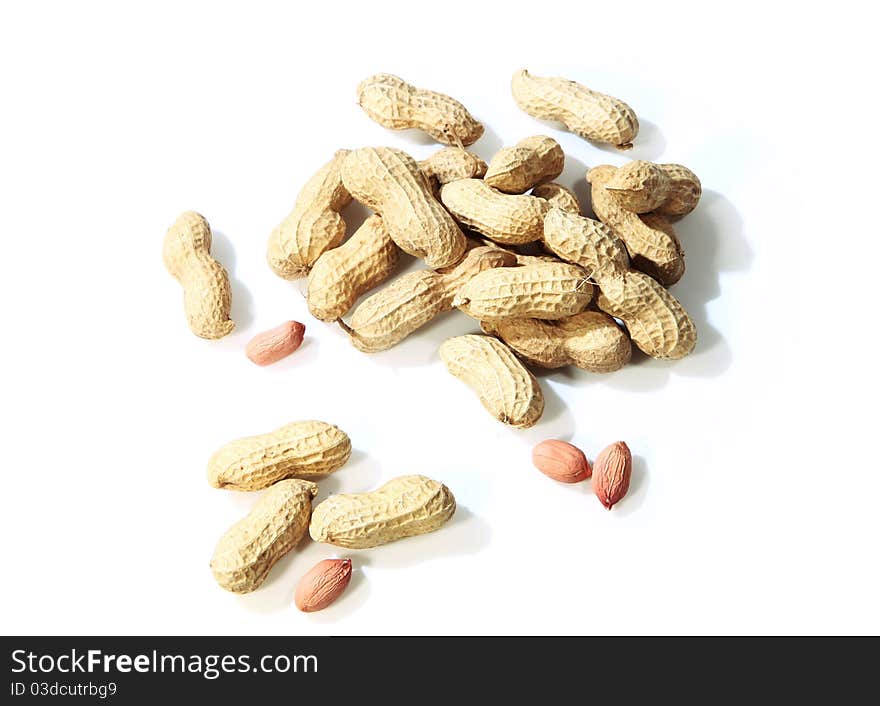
[481,311,632,373]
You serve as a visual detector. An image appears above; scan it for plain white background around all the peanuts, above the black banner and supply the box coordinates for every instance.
[0,1,880,635]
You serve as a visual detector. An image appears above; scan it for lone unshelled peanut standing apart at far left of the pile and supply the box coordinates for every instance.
[162,211,235,338]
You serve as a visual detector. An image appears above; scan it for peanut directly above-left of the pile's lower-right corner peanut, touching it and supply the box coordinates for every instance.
[544,208,630,282]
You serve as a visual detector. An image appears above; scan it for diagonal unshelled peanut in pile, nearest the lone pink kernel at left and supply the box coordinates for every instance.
[306,215,400,321]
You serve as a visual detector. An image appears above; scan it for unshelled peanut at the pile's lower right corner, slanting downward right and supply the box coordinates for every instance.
[597,270,697,359]
